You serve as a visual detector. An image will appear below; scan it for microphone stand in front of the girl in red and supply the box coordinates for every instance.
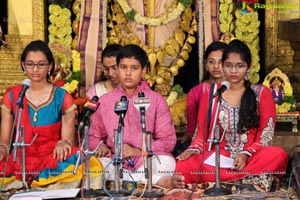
[204,94,232,196]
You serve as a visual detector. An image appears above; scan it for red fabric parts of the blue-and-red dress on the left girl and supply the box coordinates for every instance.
[0,86,78,179]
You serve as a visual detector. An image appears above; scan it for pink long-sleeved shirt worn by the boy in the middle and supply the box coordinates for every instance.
[89,82,176,168]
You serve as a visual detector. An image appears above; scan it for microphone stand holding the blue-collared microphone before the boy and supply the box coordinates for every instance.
[109,113,131,197]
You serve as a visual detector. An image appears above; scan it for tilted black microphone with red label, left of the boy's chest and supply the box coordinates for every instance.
[78,96,100,130]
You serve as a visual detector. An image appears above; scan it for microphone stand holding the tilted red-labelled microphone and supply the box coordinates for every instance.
[73,121,103,197]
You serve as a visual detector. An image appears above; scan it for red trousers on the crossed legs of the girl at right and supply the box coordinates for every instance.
[176,146,287,183]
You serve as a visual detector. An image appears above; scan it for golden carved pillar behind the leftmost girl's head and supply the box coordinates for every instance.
[0,0,47,98]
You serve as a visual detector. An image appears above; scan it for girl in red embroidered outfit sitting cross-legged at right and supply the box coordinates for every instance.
[176,40,287,191]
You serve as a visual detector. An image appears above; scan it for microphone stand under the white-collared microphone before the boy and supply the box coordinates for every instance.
[135,107,164,198]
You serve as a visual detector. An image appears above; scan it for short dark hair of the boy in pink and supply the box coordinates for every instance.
[117,44,149,68]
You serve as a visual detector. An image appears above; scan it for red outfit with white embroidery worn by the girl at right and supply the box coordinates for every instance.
[176,85,287,190]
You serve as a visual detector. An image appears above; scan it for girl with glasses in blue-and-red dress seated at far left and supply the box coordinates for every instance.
[0,40,101,188]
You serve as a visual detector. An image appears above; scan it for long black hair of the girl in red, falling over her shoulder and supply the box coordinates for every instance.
[222,40,259,133]
